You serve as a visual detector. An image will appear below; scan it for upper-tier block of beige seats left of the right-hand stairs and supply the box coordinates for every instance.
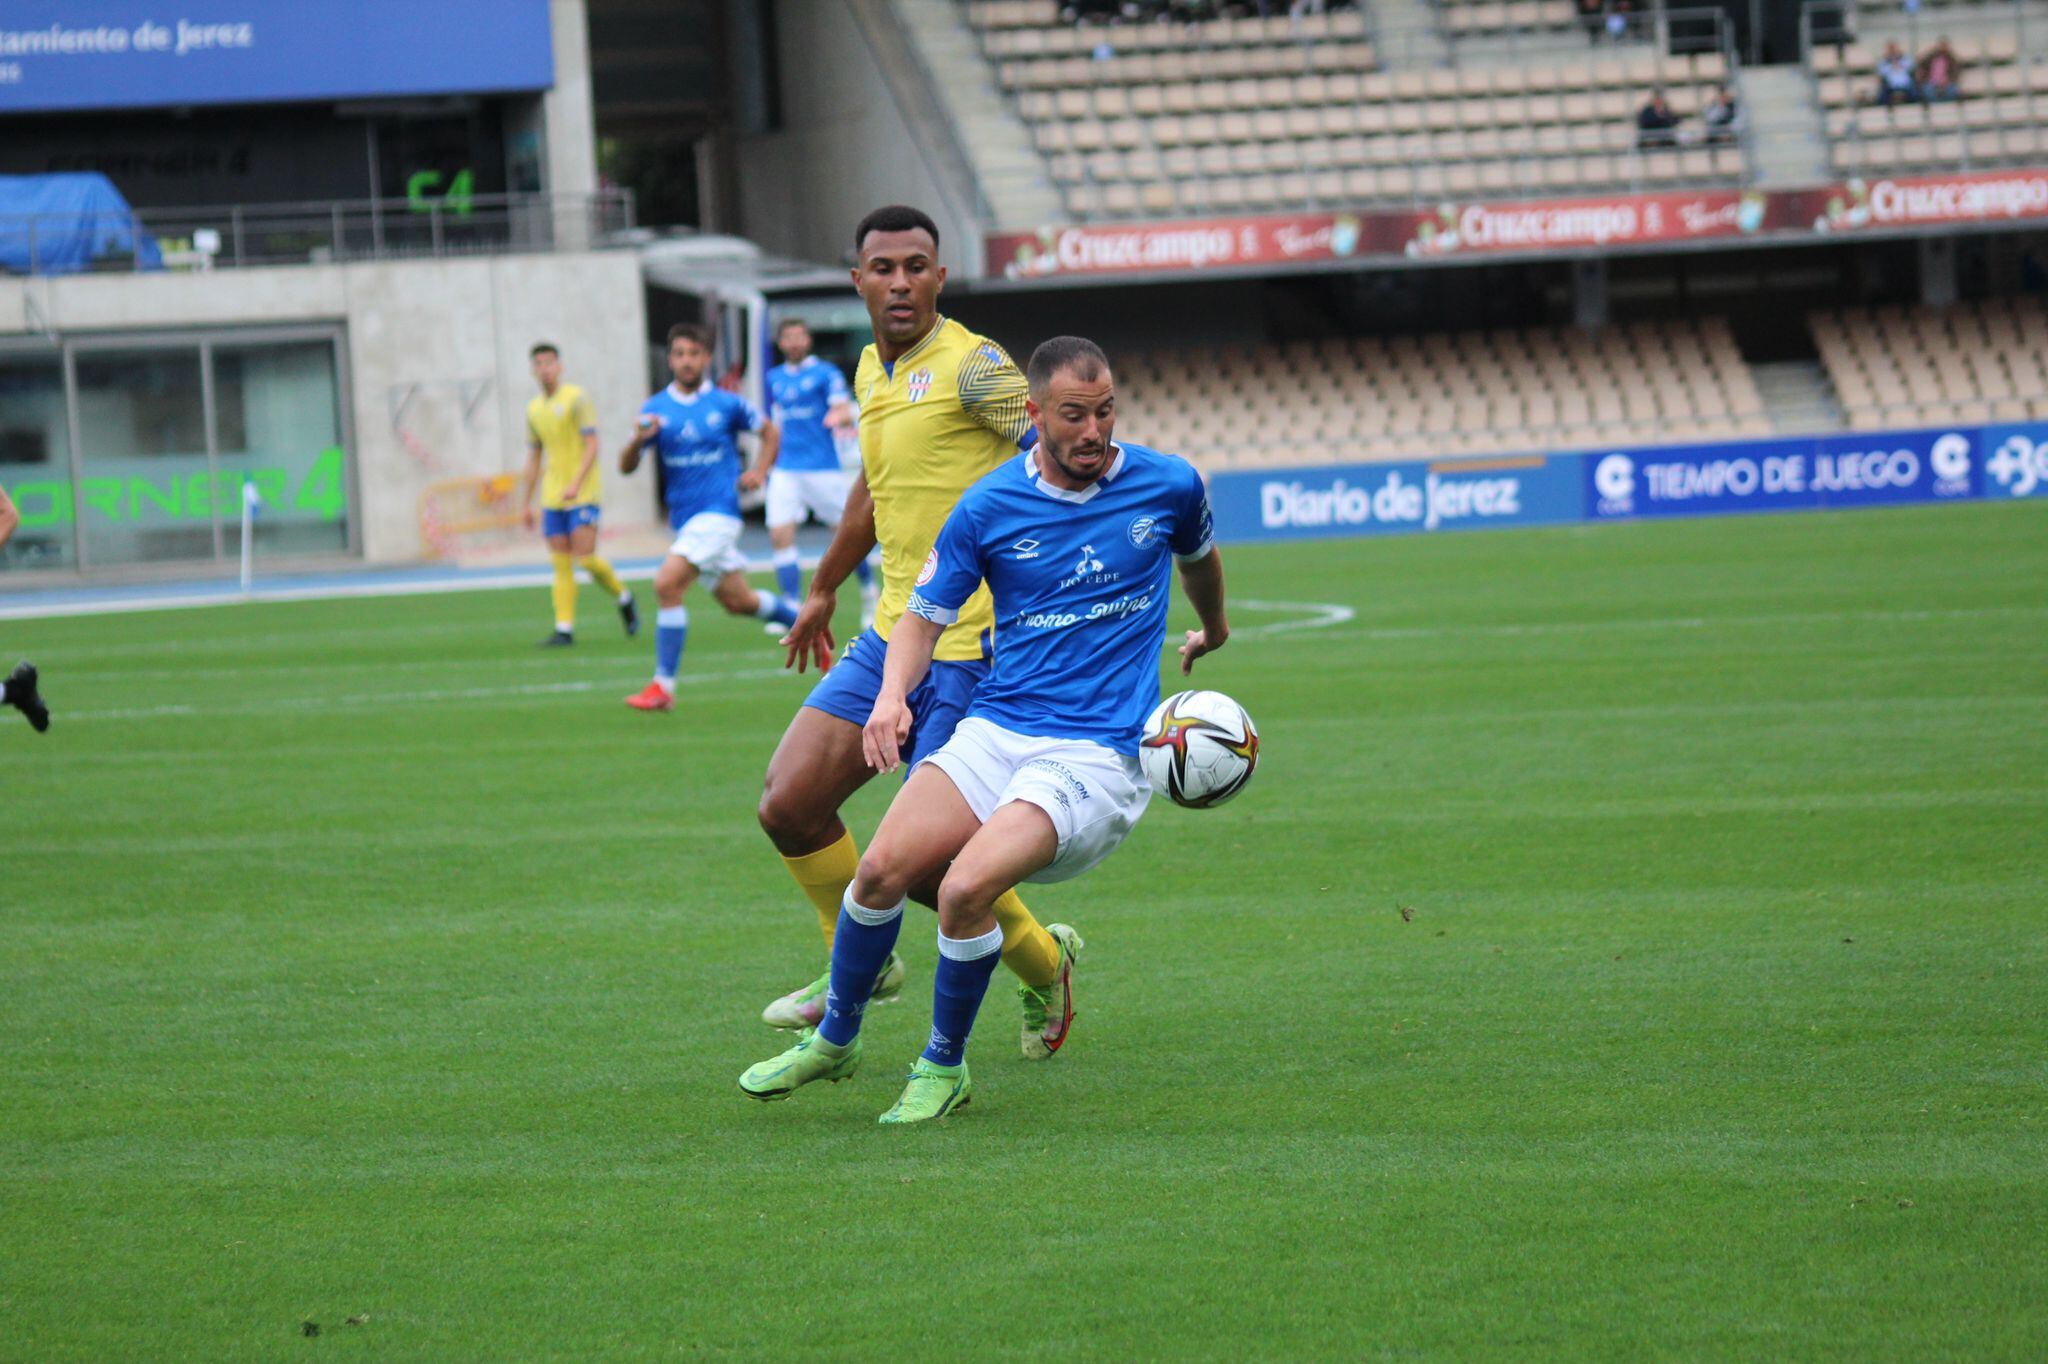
[965,0,1745,221]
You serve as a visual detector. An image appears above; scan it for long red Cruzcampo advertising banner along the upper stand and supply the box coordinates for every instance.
[987,170,2048,283]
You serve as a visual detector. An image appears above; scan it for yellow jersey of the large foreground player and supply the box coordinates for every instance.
[854,317,1030,662]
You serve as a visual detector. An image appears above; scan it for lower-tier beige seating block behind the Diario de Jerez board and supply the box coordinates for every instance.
[1118,319,1769,469]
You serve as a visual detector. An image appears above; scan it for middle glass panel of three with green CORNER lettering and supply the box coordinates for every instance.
[76,346,215,567]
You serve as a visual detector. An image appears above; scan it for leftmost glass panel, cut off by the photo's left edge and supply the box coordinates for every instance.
[0,352,78,569]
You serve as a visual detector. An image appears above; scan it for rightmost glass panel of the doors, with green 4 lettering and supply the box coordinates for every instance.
[213,340,348,555]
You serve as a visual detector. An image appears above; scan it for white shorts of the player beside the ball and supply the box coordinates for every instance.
[920,715,1151,881]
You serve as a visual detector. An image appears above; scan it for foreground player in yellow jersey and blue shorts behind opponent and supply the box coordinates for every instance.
[760,205,1083,1061]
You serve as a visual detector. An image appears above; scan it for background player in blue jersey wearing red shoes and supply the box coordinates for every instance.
[618,322,797,711]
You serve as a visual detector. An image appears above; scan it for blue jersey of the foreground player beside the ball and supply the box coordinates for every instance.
[909,444,1212,754]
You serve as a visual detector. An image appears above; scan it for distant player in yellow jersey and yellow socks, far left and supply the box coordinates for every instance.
[520,342,639,647]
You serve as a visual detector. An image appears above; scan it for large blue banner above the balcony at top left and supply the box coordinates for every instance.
[0,0,555,113]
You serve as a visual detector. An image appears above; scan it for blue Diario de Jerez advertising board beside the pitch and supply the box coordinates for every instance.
[1208,455,1581,541]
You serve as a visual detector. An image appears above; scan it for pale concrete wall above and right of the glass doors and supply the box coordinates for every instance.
[0,252,657,563]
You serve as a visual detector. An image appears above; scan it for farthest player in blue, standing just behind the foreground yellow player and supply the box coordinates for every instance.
[768,317,874,635]
